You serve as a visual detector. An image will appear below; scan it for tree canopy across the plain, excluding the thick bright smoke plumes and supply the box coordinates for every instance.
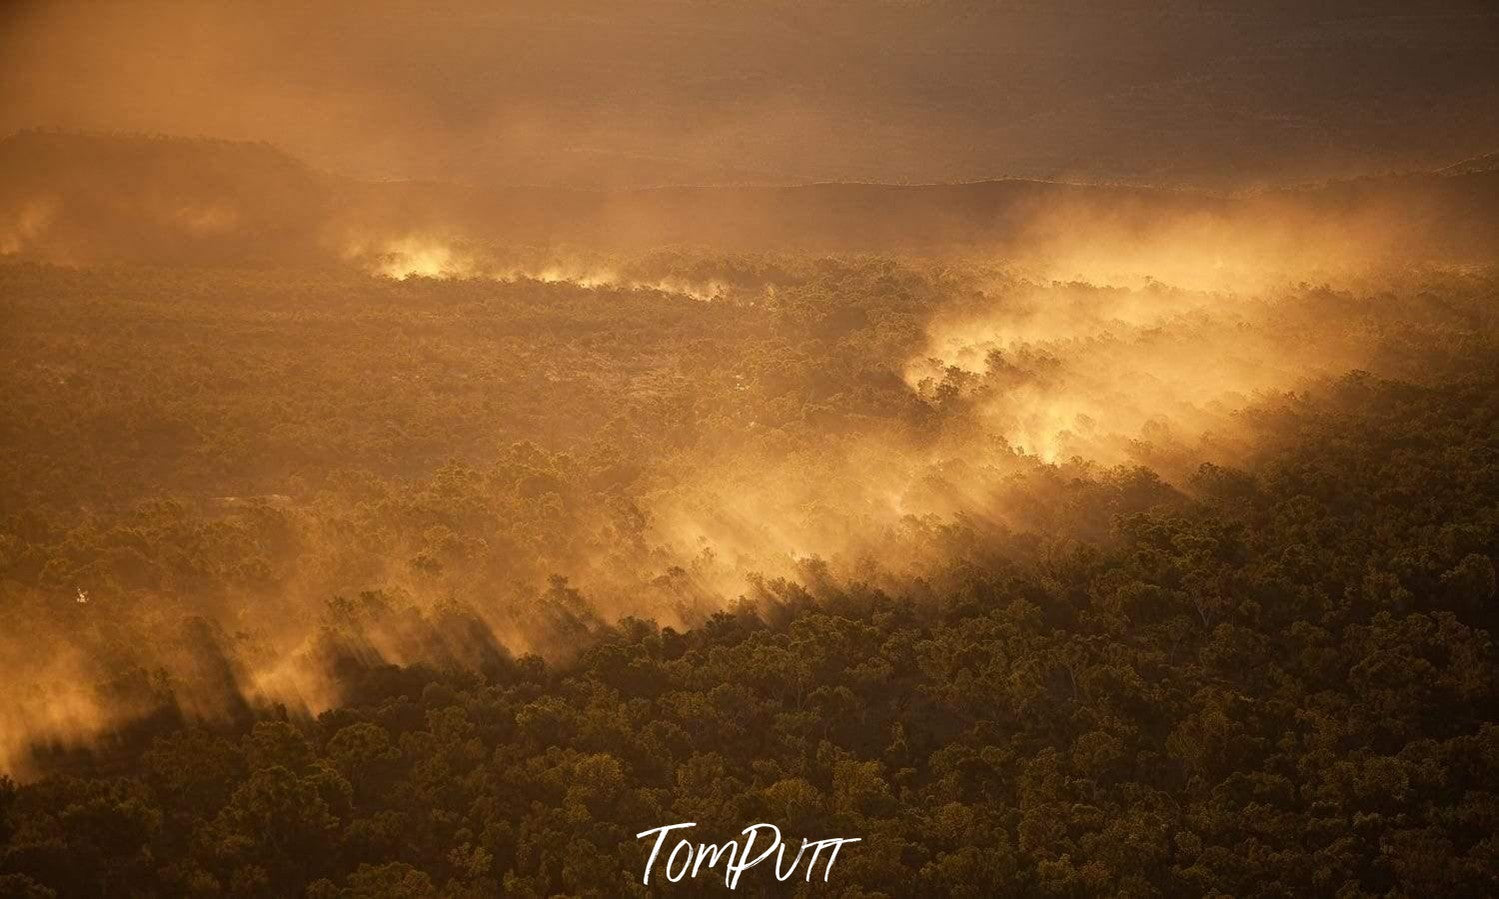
[0,261,1499,898]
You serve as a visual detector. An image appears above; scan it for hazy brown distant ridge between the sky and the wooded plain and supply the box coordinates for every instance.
[0,132,1499,265]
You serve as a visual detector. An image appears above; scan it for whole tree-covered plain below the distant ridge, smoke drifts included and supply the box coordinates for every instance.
[0,241,1499,898]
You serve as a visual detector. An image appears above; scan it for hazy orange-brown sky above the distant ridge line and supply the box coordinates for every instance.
[0,0,1499,184]
